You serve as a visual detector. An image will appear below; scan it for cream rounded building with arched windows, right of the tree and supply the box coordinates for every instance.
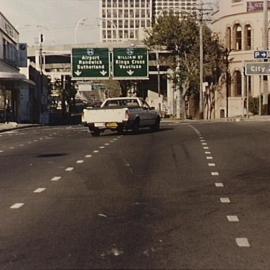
[212,0,270,118]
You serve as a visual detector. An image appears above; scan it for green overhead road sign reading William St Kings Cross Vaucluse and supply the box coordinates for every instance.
[113,48,149,80]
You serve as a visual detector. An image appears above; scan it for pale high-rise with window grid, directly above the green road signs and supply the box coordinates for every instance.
[100,0,154,42]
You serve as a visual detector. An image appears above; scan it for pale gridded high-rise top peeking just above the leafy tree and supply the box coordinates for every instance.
[153,0,200,18]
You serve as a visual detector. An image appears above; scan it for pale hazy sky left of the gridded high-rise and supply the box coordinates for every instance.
[0,0,100,45]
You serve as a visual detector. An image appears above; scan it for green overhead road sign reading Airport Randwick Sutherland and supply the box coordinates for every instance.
[72,48,110,80]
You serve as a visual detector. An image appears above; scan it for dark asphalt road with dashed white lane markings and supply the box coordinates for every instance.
[0,122,270,270]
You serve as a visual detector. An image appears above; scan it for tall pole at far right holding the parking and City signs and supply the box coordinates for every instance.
[262,0,268,114]
